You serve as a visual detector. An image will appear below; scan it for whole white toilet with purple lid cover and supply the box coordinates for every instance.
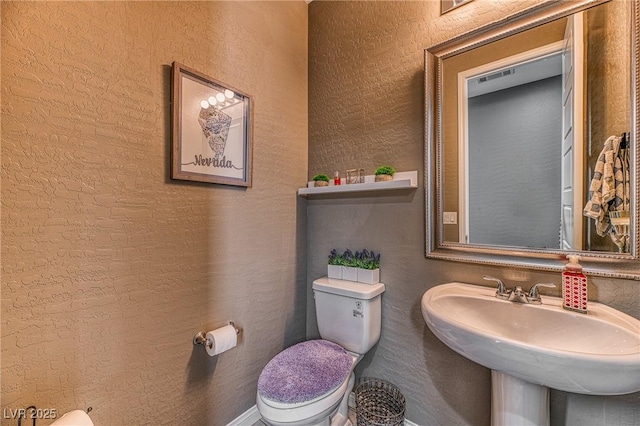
[256,277,385,426]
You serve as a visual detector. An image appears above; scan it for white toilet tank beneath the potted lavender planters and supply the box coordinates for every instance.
[313,277,385,354]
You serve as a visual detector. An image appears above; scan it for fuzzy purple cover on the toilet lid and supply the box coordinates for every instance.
[258,340,353,404]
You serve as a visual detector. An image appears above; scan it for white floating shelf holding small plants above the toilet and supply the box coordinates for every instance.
[298,170,418,197]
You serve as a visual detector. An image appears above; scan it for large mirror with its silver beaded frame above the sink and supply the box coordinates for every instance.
[425,0,640,279]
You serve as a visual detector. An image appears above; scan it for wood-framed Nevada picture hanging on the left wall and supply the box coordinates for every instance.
[171,62,252,187]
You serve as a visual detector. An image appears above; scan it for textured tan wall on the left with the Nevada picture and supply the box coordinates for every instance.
[1,1,308,425]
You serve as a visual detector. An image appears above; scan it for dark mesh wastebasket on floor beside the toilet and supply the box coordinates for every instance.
[355,379,406,426]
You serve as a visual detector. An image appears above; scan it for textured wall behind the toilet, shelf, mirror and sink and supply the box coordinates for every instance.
[307,0,640,426]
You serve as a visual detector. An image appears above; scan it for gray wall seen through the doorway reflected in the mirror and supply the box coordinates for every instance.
[468,76,562,248]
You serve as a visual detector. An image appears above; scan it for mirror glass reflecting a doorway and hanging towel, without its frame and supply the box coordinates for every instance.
[440,2,635,253]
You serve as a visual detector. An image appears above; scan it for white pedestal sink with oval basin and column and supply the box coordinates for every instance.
[422,283,640,426]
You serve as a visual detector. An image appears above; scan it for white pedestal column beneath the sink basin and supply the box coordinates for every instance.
[491,370,549,426]
